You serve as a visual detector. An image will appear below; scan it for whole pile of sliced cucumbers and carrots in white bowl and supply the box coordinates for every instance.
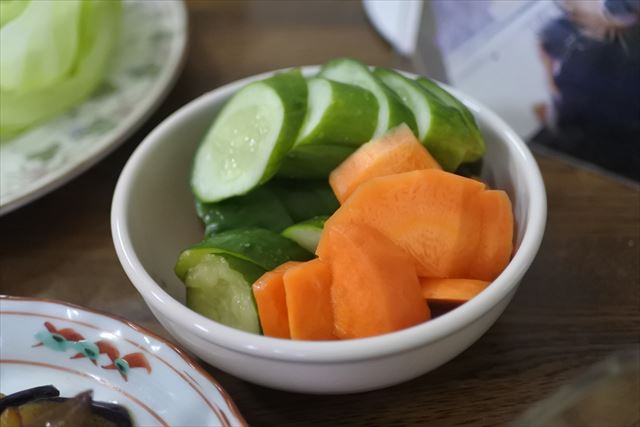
[175,59,514,340]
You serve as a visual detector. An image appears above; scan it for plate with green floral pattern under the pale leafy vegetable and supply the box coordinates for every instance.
[0,0,187,215]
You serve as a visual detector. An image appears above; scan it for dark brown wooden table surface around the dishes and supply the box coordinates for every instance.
[0,1,640,426]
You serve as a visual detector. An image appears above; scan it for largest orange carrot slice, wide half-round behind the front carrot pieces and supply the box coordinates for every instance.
[324,169,485,278]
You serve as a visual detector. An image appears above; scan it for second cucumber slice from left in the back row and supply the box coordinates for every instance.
[293,77,378,151]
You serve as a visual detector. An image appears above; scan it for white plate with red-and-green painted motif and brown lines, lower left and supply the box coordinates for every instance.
[0,295,246,426]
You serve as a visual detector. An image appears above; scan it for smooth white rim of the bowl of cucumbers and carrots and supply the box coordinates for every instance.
[111,66,547,363]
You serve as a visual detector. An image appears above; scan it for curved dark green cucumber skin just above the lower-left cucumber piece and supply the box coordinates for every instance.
[175,228,313,277]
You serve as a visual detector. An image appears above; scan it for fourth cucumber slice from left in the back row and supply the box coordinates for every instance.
[374,68,484,172]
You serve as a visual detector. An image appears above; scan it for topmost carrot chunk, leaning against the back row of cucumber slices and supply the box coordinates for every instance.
[329,124,442,203]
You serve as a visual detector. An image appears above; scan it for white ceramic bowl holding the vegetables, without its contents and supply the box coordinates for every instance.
[111,67,546,393]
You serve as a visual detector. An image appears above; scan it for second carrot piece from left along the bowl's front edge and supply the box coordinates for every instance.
[283,258,336,340]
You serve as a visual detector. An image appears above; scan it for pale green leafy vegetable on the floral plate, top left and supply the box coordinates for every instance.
[0,0,122,139]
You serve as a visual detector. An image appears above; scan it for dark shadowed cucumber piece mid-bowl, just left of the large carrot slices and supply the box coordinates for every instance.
[269,179,340,222]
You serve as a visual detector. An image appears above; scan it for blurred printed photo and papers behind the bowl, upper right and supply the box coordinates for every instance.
[364,0,640,181]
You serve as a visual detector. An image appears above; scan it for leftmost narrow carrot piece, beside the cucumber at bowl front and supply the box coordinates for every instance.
[252,261,300,338]
